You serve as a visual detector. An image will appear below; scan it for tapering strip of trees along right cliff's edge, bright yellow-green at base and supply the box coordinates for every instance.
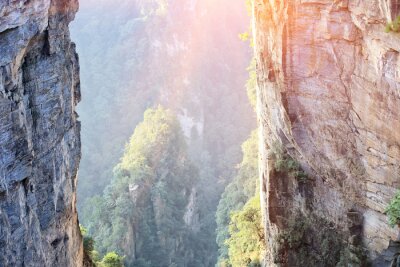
[216,131,263,266]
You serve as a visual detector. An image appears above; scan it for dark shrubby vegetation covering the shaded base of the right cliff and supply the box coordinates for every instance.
[275,213,367,267]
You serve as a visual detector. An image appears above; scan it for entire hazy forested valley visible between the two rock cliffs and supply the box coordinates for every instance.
[72,0,263,266]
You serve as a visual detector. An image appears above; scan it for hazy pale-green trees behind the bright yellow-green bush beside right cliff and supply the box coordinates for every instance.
[216,130,258,266]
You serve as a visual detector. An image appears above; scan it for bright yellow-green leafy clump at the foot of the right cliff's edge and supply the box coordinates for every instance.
[226,196,265,267]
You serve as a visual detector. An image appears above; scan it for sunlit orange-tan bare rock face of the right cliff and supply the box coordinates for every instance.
[253,0,400,266]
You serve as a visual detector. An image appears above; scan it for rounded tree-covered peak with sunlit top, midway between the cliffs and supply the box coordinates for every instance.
[84,107,197,266]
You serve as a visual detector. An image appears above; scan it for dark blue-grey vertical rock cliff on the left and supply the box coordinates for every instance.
[0,0,83,266]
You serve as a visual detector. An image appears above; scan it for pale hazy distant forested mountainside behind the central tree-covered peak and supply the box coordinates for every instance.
[71,0,255,206]
